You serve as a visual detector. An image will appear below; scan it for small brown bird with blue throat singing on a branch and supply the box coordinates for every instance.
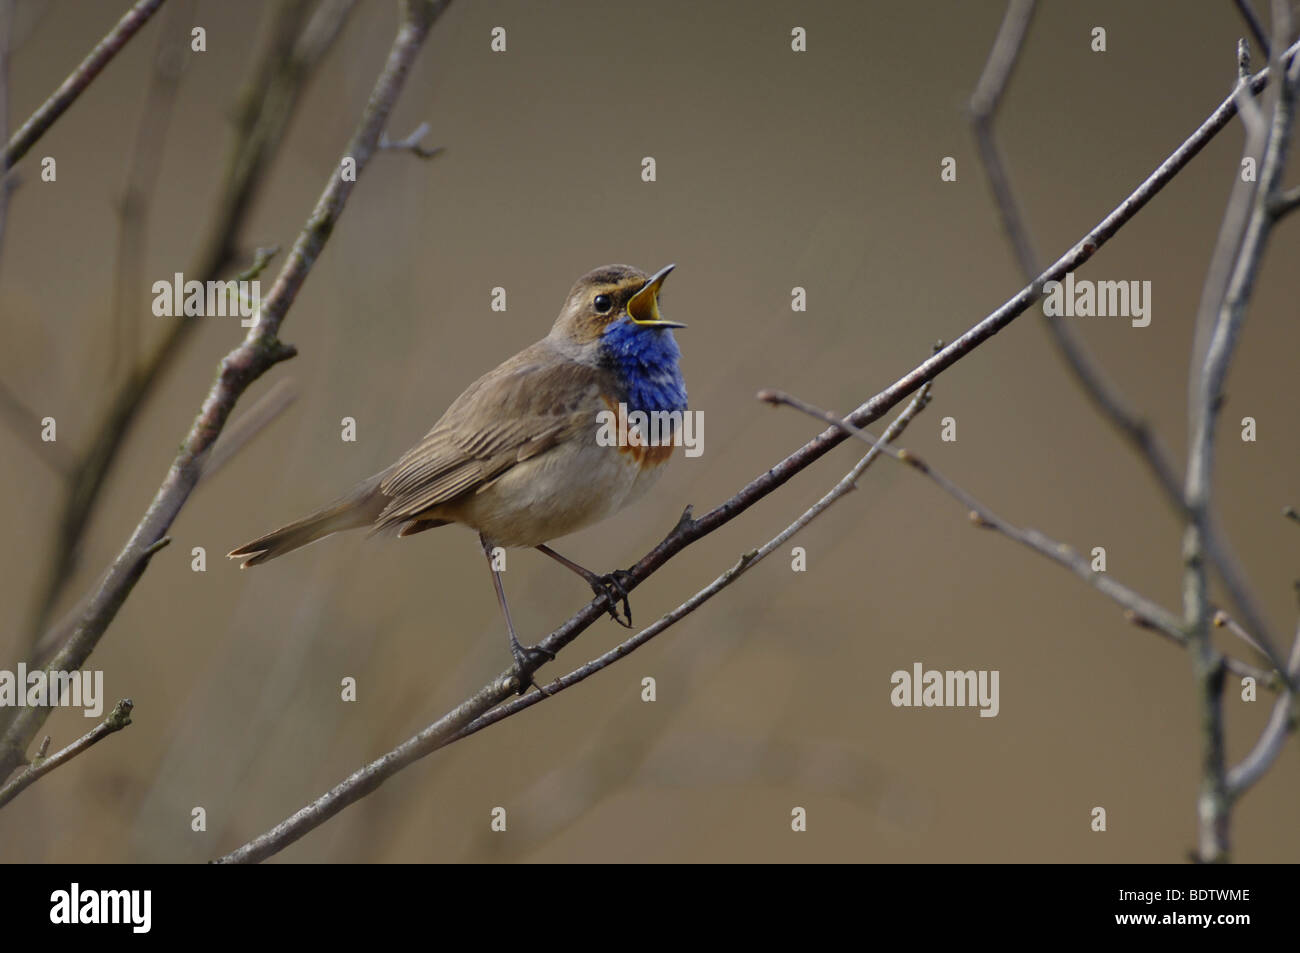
[229,265,686,670]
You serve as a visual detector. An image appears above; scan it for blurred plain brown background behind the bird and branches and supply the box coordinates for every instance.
[0,0,1300,861]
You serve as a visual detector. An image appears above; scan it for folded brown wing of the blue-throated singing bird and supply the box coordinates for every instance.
[376,341,612,528]
